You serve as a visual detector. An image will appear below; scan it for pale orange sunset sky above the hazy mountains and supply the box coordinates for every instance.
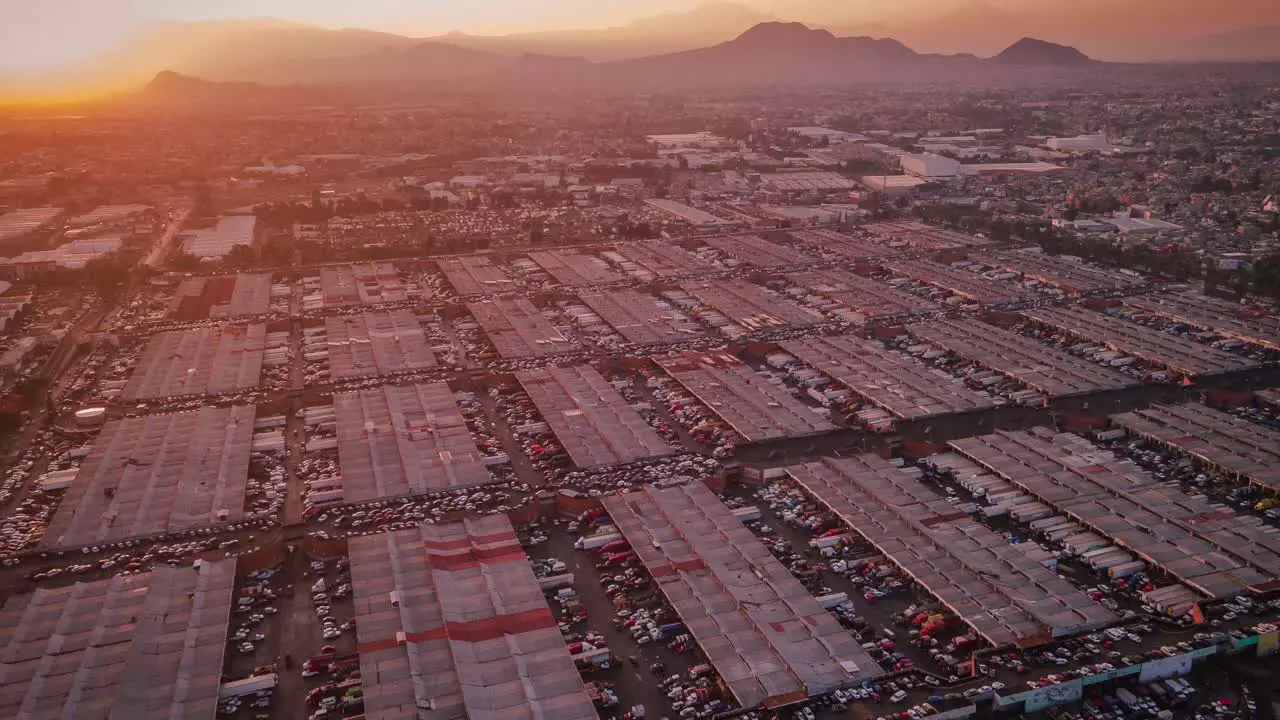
[0,0,1280,70]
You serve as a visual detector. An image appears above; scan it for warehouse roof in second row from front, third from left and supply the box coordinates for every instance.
[516,365,676,469]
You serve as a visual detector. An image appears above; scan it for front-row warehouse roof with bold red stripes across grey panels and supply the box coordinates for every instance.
[347,515,598,720]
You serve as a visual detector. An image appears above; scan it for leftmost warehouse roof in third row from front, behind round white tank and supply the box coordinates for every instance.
[120,323,266,402]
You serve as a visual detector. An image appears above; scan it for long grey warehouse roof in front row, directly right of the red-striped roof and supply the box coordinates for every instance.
[602,483,881,707]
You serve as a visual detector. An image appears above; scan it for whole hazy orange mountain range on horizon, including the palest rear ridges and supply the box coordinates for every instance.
[0,0,1280,97]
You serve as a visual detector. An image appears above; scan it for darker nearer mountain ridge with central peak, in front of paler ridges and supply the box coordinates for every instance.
[124,22,1111,96]
